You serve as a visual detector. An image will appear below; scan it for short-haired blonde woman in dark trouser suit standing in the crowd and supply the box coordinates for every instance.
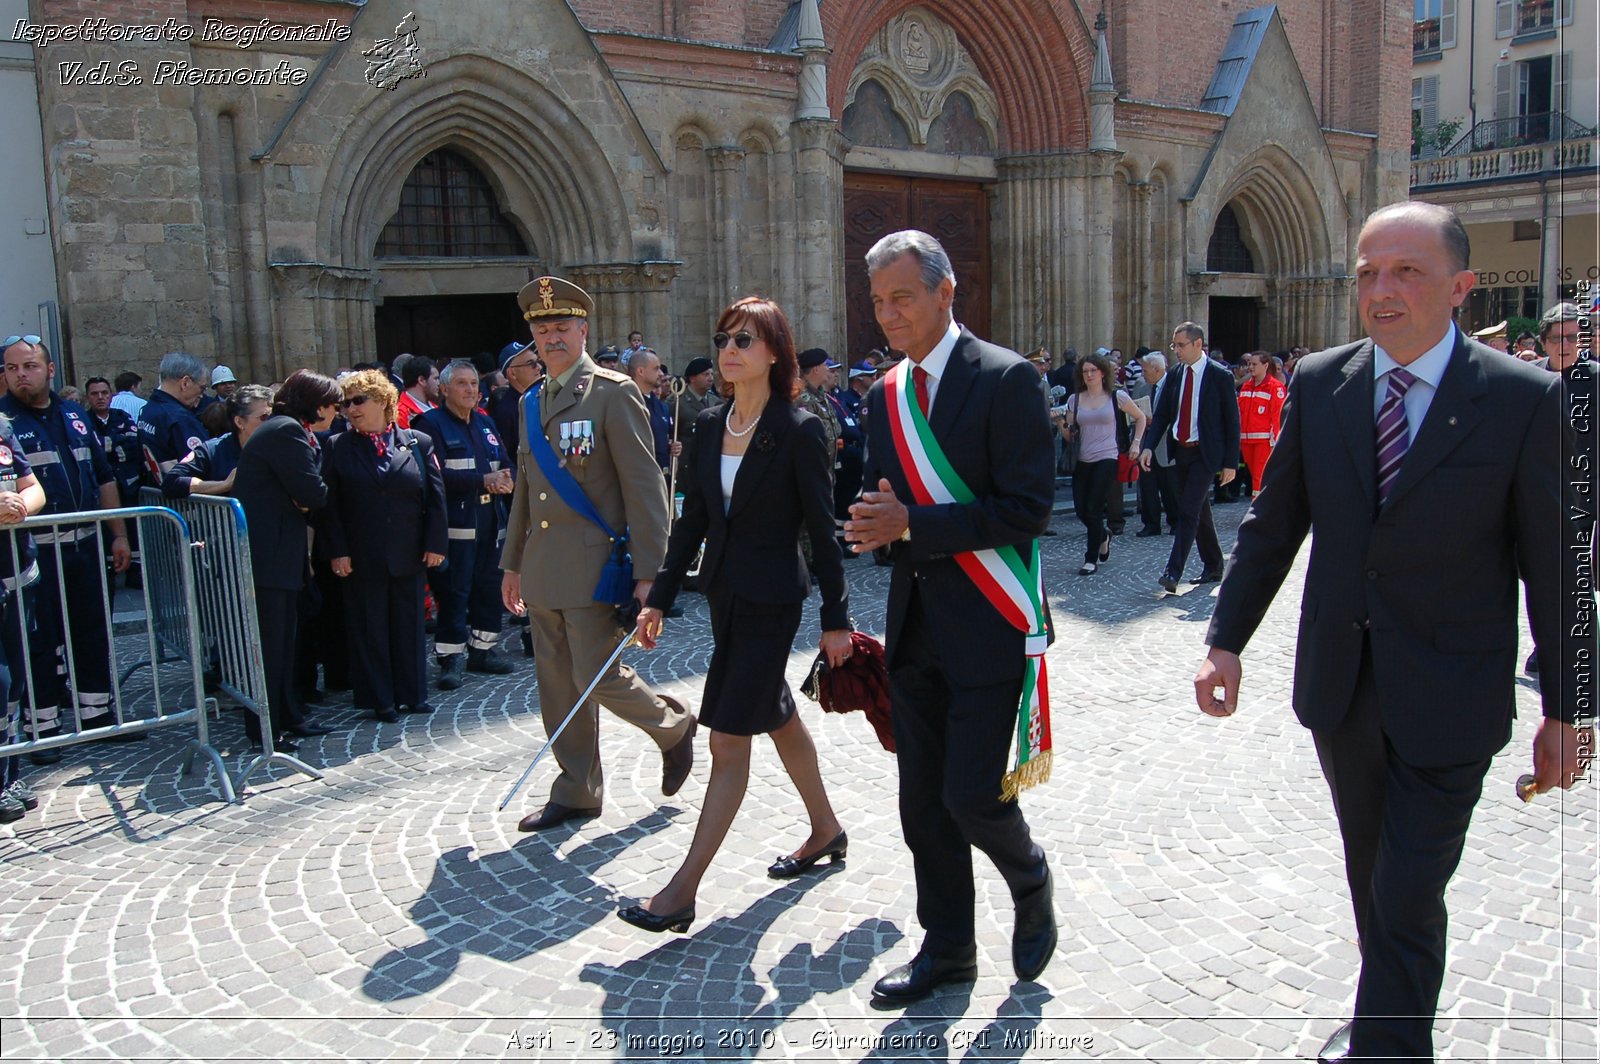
[322,370,446,723]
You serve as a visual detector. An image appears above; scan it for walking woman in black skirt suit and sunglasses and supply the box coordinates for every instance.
[618,298,850,931]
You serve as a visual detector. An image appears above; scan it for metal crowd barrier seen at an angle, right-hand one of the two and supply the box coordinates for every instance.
[139,488,322,789]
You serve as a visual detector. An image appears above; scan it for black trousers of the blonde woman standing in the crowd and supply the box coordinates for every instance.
[344,570,427,709]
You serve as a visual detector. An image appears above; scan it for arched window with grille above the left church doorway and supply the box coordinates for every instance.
[376,149,528,259]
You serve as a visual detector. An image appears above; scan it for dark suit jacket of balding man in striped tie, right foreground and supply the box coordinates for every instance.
[1206,334,1576,766]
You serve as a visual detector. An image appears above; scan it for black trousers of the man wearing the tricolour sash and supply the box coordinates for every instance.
[890,590,1046,957]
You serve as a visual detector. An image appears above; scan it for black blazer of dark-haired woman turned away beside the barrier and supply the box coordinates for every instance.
[234,414,328,590]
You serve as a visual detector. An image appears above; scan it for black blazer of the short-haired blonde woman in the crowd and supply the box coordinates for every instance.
[320,427,448,576]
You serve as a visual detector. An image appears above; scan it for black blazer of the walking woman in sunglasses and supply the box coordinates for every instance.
[650,395,850,630]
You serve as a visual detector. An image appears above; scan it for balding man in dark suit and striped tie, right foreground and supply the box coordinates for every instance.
[1195,203,1594,1061]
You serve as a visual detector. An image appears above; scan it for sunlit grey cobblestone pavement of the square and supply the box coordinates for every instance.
[0,506,1600,1061]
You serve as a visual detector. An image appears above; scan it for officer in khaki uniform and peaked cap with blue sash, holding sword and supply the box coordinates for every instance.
[501,277,694,832]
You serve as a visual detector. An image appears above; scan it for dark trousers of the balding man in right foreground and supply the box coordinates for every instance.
[1312,645,1490,1061]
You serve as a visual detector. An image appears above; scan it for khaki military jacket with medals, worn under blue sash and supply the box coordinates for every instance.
[501,354,667,610]
